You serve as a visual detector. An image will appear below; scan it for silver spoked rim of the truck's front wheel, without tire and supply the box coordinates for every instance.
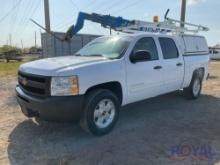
[93,99,115,128]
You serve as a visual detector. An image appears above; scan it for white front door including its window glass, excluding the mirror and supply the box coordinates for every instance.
[126,37,163,103]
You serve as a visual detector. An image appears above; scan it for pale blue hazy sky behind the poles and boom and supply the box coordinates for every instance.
[0,0,220,47]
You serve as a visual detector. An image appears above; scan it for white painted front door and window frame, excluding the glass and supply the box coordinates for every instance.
[125,35,163,103]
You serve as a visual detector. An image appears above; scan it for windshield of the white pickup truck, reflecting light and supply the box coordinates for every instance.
[76,37,129,59]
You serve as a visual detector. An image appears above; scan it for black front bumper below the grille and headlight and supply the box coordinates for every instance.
[15,86,84,122]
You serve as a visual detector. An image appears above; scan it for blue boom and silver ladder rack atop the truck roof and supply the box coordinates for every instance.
[65,10,209,40]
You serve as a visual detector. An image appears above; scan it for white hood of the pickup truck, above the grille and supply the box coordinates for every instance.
[19,56,107,76]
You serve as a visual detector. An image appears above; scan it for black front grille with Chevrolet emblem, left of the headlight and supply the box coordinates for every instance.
[18,72,50,96]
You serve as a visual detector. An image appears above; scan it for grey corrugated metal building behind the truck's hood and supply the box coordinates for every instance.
[41,32,100,58]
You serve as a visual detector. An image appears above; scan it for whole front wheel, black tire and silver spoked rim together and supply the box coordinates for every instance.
[80,89,120,136]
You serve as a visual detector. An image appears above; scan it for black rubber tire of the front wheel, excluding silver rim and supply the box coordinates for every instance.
[80,89,120,136]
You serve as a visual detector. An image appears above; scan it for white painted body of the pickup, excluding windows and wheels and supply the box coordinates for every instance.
[20,33,209,105]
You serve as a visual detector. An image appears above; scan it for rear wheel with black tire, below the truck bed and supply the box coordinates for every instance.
[183,73,202,100]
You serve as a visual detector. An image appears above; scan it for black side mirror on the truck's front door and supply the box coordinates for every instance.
[130,50,151,63]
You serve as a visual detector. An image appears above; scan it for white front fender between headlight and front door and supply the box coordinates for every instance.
[72,59,127,103]
